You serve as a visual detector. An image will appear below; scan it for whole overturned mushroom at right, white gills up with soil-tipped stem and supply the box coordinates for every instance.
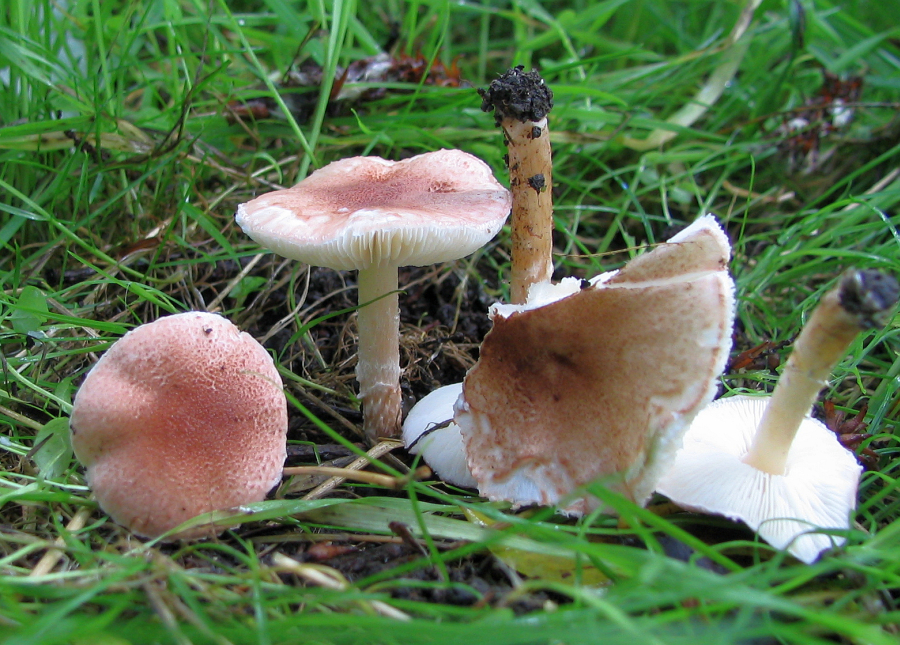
[656,270,897,563]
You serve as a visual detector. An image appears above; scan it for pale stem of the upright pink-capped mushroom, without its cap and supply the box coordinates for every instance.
[356,265,400,442]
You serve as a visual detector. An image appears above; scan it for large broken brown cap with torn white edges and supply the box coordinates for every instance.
[456,216,734,512]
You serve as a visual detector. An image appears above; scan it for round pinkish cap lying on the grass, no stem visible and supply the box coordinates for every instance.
[70,312,287,538]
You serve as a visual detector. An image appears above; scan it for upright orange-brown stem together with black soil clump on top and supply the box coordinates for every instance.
[478,66,553,304]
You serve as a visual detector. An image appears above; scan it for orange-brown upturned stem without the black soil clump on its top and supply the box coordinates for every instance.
[500,117,553,304]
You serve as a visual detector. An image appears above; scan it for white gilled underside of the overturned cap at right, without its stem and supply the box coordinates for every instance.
[656,396,862,564]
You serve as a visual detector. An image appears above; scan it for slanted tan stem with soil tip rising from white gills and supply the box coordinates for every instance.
[744,269,897,475]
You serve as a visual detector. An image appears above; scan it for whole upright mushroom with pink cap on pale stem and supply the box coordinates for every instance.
[236,150,510,440]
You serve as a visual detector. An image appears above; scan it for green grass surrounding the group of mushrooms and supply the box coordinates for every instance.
[0,0,900,645]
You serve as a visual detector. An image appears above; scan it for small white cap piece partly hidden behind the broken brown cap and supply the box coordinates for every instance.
[403,383,478,488]
